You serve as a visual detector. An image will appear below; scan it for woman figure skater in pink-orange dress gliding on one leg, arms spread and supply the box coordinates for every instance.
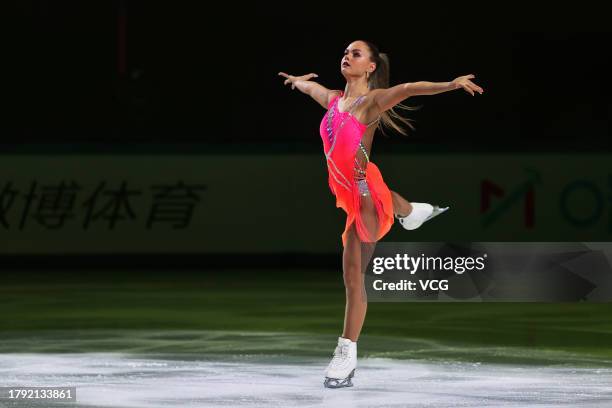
[279,40,483,388]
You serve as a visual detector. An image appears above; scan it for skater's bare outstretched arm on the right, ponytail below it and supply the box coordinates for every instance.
[372,74,484,112]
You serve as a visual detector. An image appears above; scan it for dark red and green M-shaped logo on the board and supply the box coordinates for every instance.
[480,169,542,228]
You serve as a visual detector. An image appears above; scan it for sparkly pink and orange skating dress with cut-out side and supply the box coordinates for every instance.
[319,92,394,246]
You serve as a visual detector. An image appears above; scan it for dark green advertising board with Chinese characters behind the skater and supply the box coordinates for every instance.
[0,153,612,254]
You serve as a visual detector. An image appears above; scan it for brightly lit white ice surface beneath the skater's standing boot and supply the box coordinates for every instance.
[0,333,612,408]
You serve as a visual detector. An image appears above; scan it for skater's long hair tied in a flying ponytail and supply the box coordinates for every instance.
[361,40,421,136]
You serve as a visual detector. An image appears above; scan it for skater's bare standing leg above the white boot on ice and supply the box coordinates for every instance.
[342,196,378,342]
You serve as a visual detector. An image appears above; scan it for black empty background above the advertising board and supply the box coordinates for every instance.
[3,0,612,151]
